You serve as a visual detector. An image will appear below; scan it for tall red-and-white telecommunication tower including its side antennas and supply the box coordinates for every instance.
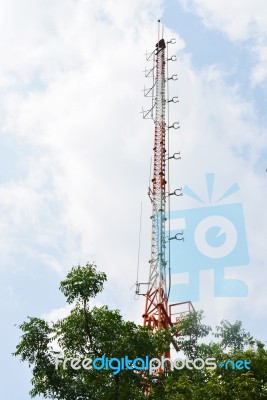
[136,21,193,356]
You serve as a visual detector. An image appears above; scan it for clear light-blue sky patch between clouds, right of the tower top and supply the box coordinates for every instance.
[163,0,265,113]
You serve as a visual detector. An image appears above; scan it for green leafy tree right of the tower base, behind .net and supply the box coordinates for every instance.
[164,311,267,400]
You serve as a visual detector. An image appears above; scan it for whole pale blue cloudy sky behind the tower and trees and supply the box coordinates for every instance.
[0,0,267,400]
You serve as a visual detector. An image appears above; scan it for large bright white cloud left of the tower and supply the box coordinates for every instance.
[0,0,165,296]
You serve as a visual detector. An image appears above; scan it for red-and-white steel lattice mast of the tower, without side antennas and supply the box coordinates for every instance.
[143,39,171,329]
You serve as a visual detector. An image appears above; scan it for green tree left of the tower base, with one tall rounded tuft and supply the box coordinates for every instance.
[14,263,169,400]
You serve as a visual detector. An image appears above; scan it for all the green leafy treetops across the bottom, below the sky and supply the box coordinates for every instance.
[14,263,267,400]
